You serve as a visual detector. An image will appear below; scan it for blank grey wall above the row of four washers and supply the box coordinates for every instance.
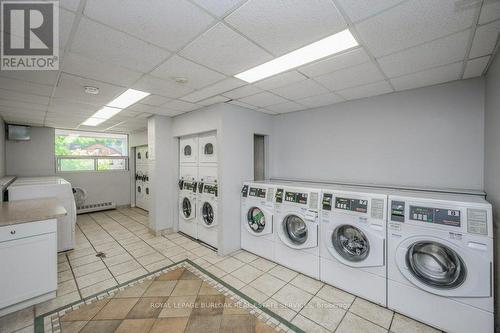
[271,78,484,190]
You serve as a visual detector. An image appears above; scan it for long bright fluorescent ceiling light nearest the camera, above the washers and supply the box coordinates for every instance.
[235,29,359,83]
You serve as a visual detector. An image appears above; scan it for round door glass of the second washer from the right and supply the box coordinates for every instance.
[332,224,370,262]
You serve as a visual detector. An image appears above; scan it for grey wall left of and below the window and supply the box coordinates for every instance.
[5,127,130,205]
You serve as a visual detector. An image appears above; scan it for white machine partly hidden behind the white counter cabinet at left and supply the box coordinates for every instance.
[8,177,76,252]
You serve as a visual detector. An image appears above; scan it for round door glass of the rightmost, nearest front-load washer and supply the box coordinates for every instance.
[406,241,467,289]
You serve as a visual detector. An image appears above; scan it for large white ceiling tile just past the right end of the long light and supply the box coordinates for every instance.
[356,0,475,57]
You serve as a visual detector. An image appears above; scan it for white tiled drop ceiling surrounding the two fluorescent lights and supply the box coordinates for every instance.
[0,0,500,132]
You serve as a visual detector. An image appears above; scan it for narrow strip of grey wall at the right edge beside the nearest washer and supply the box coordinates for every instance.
[484,52,500,331]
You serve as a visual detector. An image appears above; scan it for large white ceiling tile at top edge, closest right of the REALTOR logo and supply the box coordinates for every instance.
[85,0,214,51]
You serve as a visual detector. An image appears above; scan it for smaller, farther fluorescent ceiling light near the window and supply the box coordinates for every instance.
[82,89,150,126]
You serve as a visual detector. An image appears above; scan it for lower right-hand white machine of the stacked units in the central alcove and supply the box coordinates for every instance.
[197,183,218,248]
